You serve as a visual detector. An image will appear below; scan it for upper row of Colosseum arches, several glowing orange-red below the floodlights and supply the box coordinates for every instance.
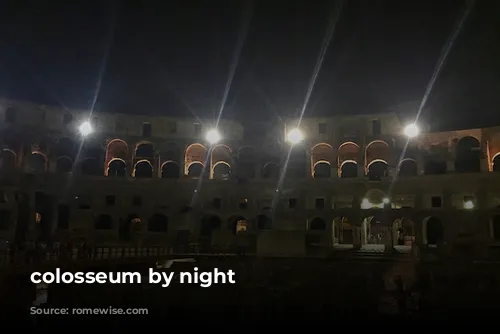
[0,136,492,181]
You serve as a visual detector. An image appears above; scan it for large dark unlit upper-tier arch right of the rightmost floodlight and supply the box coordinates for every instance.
[455,137,481,173]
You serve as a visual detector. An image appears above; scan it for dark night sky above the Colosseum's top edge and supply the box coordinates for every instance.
[0,0,500,124]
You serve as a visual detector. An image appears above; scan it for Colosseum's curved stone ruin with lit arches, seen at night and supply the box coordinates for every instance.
[0,100,500,256]
